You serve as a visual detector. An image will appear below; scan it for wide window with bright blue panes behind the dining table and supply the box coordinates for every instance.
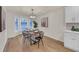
[15,18,33,31]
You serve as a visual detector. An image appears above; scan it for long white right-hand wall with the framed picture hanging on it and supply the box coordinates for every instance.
[37,7,64,41]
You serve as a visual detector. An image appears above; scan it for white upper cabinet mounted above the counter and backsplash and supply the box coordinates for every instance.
[65,6,79,23]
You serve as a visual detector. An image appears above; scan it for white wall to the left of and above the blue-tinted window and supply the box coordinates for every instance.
[7,12,26,38]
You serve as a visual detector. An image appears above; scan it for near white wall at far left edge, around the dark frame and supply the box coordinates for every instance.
[0,7,7,52]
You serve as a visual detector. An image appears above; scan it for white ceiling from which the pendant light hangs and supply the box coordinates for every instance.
[4,6,61,16]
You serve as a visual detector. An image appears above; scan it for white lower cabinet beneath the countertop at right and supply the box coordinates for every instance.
[64,32,79,51]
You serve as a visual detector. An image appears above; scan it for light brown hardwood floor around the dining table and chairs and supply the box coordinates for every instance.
[4,35,72,52]
